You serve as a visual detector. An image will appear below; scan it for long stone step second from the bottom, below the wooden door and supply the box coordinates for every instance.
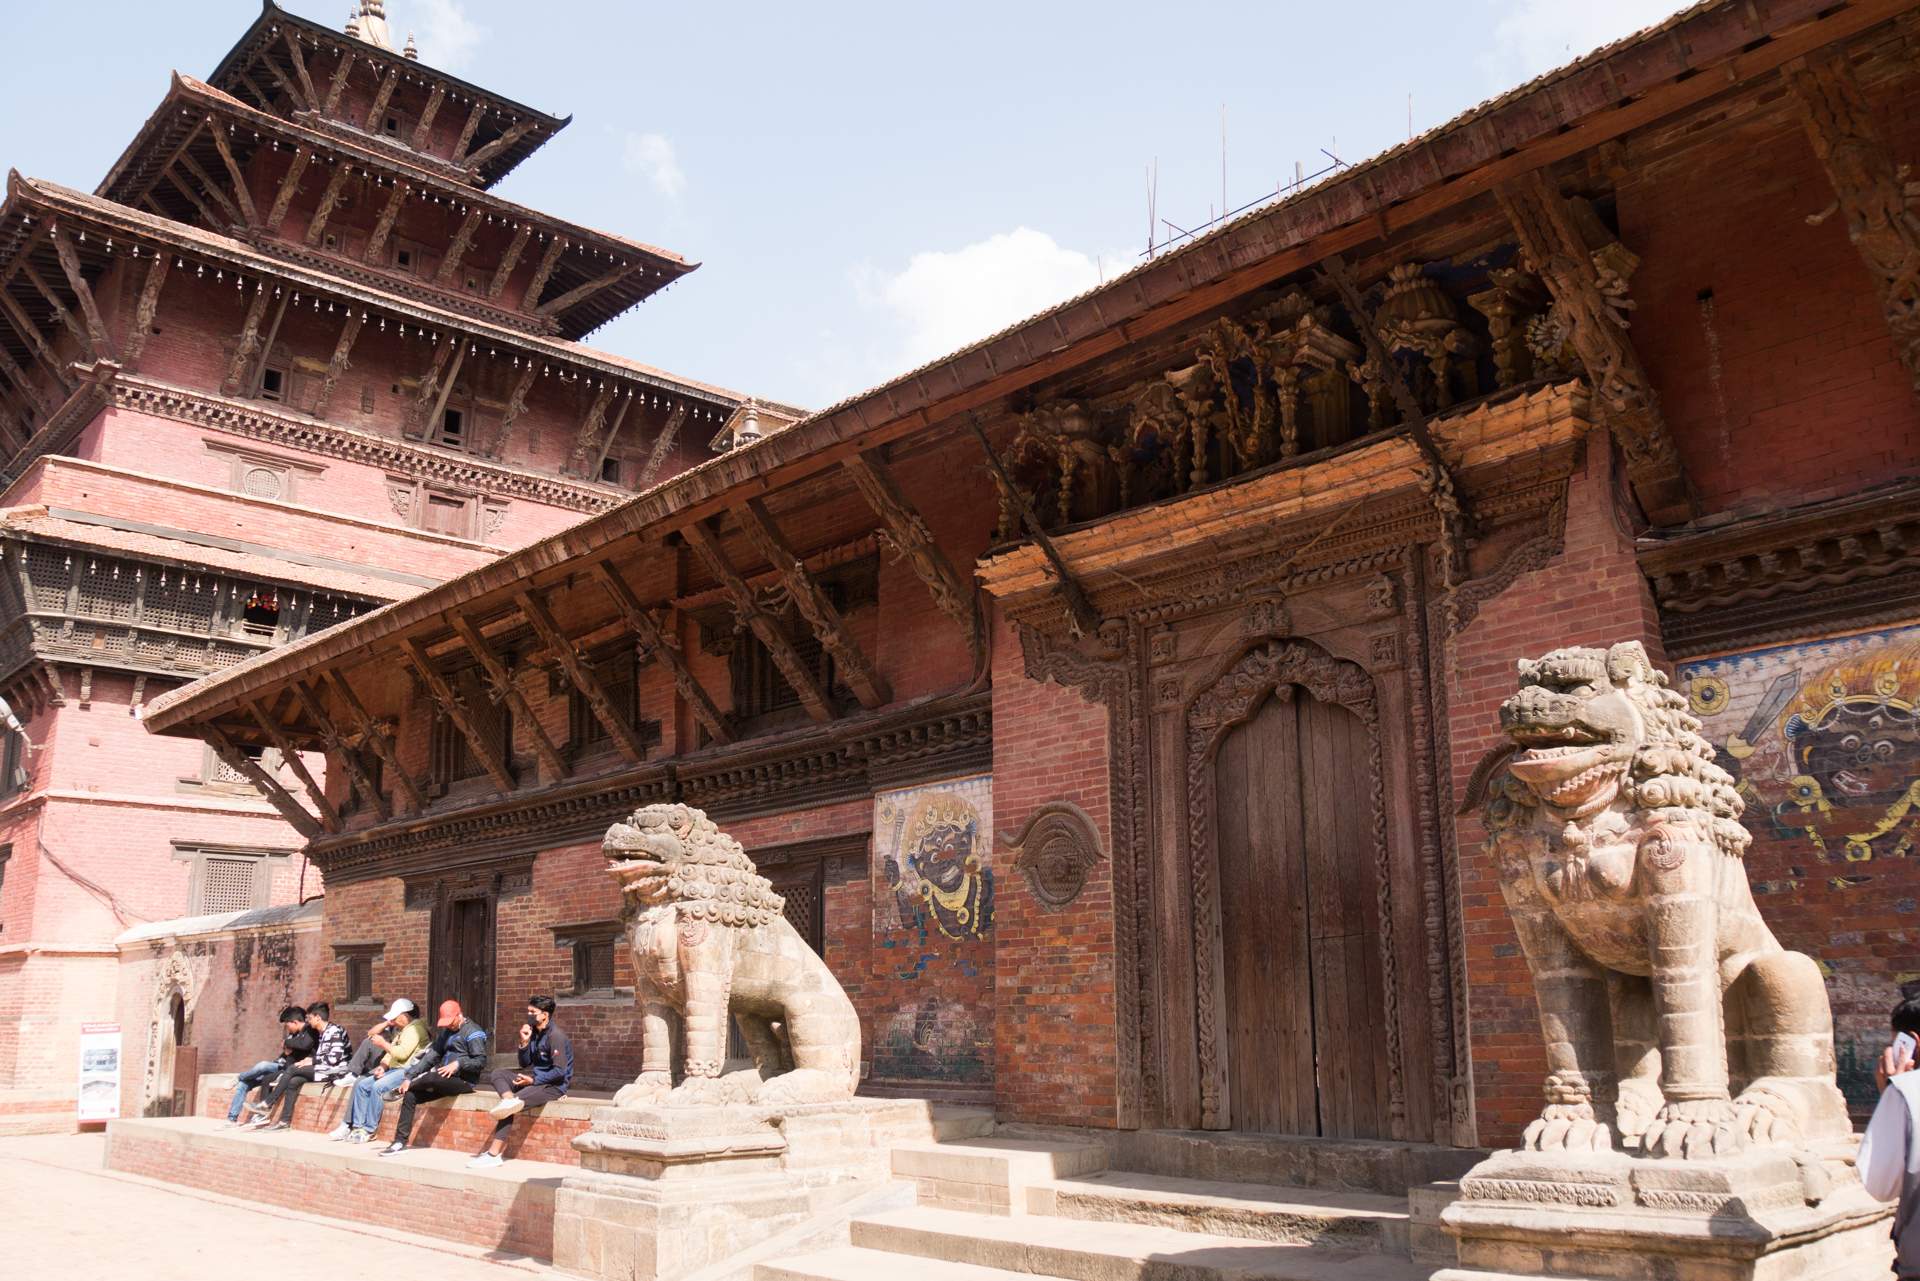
[848,1206,1432,1281]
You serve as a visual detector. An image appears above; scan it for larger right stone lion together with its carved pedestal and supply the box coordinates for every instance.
[1434,641,1893,1281]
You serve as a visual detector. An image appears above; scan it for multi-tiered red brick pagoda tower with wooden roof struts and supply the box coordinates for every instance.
[0,0,799,1133]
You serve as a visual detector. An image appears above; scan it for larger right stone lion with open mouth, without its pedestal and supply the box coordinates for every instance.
[1469,641,1851,1158]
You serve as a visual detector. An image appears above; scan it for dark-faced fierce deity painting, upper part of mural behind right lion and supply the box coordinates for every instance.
[1678,628,1920,862]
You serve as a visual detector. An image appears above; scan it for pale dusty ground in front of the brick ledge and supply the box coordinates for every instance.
[0,1133,557,1281]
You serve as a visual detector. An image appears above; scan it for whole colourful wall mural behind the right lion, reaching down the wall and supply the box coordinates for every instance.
[1676,628,1920,1104]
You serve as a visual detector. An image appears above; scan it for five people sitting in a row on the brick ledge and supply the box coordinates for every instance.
[221,997,574,1168]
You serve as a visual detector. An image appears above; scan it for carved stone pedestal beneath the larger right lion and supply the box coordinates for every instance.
[1432,1141,1893,1281]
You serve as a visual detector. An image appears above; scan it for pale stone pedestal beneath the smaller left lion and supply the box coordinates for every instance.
[553,1099,935,1281]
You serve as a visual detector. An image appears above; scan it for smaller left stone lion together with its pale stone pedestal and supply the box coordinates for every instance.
[553,805,935,1281]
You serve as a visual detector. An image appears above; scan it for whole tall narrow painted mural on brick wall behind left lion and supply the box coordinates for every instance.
[872,774,995,1087]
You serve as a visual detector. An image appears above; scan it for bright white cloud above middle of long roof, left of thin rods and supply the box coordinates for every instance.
[849,227,1131,369]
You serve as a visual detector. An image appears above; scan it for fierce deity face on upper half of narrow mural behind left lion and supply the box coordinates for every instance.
[874,776,993,939]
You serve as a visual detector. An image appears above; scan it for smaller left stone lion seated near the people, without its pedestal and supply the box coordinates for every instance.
[601,805,860,1108]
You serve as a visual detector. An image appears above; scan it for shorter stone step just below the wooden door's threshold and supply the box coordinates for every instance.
[1027,1170,1409,1254]
